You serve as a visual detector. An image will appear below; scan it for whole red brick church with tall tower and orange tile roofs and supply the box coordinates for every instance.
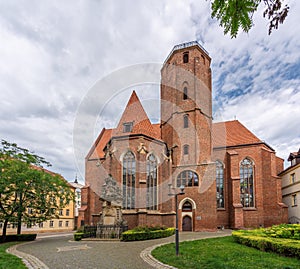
[79,41,288,231]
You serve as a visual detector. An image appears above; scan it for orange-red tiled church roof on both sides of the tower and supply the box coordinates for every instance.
[87,91,263,159]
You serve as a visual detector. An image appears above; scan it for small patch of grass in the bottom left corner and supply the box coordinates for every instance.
[0,242,27,269]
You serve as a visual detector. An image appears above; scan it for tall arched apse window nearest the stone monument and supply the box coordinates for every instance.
[123,151,136,209]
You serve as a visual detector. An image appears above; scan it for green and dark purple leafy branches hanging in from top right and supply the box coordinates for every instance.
[211,0,289,37]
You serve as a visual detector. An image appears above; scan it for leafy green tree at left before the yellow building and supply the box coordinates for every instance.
[0,140,74,241]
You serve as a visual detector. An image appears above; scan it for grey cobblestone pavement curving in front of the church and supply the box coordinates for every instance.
[10,230,231,269]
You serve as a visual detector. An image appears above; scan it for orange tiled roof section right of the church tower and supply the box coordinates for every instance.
[212,120,263,147]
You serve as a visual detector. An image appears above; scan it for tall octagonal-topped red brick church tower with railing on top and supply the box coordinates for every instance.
[161,41,216,230]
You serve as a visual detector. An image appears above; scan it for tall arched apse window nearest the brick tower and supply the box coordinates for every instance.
[146,154,157,210]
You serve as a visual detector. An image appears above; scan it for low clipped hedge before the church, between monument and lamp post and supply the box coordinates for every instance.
[121,226,175,241]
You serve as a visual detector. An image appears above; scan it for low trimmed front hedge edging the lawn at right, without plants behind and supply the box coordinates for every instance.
[232,231,300,259]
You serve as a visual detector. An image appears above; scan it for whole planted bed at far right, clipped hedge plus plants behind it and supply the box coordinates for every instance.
[232,224,300,258]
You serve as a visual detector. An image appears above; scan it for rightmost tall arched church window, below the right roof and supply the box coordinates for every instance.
[240,158,254,207]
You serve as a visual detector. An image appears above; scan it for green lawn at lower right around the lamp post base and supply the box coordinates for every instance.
[152,236,300,269]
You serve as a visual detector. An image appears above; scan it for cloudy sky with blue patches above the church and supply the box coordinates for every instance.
[0,0,300,182]
